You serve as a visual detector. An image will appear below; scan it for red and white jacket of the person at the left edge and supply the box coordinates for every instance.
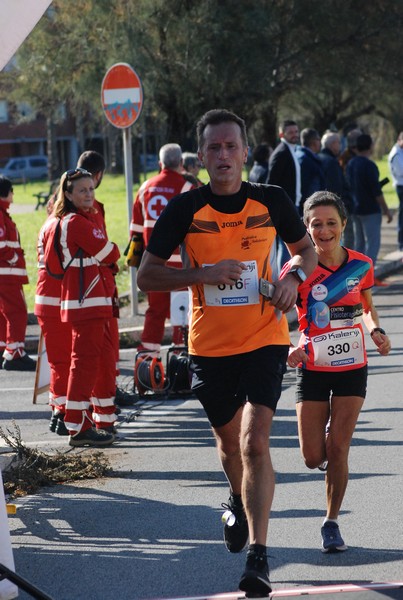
[0,201,28,286]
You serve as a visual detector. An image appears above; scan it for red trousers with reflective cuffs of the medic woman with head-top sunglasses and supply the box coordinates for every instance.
[64,319,116,435]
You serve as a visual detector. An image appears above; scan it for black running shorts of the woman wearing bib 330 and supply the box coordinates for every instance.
[296,365,368,402]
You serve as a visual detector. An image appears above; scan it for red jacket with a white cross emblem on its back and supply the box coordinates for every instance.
[130,169,194,268]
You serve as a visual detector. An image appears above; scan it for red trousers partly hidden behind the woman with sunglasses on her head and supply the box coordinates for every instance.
[38,317,71,413]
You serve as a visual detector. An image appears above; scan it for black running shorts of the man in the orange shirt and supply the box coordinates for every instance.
[190,345,288,427]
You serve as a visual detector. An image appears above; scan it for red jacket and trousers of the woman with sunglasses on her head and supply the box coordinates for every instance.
[45,211,120,435]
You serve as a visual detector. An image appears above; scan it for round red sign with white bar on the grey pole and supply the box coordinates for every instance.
[101,63,143,129]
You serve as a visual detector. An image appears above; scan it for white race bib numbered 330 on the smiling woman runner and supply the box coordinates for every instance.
[311,327,364,367]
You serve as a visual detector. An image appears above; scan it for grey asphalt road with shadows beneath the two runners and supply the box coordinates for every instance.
[0,272,403,600]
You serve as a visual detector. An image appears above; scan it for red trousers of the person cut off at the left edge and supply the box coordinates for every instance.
[0,282,28,358]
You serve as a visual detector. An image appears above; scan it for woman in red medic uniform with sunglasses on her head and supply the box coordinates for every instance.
[49,168,120,446]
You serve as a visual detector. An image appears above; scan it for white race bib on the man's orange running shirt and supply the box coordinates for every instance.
[203,260,260,307]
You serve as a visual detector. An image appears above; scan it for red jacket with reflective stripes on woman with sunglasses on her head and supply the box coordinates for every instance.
[45,212,120,322]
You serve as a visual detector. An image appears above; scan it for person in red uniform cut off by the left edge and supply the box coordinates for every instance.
[0,176,36,371]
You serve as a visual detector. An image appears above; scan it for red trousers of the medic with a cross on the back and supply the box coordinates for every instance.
[141,292,183,350]
